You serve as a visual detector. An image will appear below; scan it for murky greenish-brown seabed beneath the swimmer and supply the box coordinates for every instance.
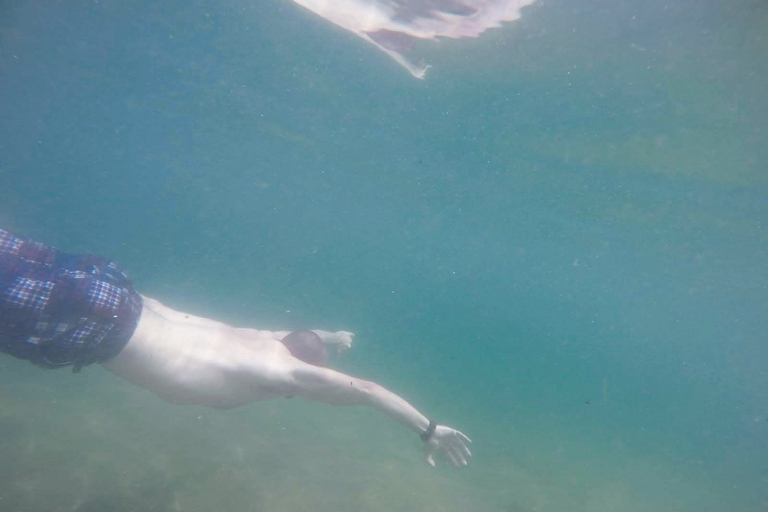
[0,359,752,512]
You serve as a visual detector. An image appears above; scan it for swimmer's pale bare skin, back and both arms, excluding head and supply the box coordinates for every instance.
[102,297,471,467]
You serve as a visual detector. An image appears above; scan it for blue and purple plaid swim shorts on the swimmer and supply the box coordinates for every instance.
[0,229,142,372]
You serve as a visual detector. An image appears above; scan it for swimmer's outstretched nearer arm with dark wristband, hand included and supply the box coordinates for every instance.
[290,364,472,467]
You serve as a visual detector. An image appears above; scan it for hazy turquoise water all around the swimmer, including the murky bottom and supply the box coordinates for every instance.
[0,0,768,512]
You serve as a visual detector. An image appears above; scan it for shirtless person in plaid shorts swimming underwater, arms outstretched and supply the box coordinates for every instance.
[0,229,471,467]
